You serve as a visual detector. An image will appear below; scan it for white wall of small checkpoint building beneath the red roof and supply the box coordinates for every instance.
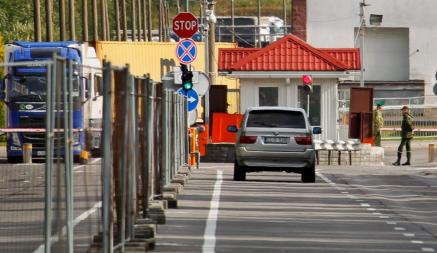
[240,78,338,140]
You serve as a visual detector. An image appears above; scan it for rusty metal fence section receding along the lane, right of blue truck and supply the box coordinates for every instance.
[102,60,189,252]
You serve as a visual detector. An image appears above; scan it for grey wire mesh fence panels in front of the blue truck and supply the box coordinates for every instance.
[0,56,101,252]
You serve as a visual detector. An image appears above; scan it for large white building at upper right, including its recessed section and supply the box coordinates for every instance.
[304,0,437,104]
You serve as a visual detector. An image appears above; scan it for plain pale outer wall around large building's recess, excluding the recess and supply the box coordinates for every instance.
[307,0,437,103]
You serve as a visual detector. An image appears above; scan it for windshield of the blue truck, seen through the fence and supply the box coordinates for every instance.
[8,76,80,101]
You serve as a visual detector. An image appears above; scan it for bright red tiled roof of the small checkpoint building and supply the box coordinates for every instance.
[219,35,360,71]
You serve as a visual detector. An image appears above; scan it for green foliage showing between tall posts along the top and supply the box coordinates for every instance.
[0,0,291,42]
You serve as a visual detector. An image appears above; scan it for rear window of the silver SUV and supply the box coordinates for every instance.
[247,110,306,128]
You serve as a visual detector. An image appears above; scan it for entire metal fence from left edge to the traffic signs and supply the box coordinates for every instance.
[0,56,189,253]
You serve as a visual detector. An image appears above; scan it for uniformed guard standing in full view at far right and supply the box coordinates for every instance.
[393,106,414,166]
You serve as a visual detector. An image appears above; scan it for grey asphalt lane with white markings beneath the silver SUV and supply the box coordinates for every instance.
[155,164,437,253]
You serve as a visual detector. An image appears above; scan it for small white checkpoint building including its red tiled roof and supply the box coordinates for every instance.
[218,35,360,140]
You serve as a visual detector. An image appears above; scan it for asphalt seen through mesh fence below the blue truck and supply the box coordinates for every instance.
[0,159,101,253]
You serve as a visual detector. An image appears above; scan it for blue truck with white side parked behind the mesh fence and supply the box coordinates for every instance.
[1,41,102,163]
